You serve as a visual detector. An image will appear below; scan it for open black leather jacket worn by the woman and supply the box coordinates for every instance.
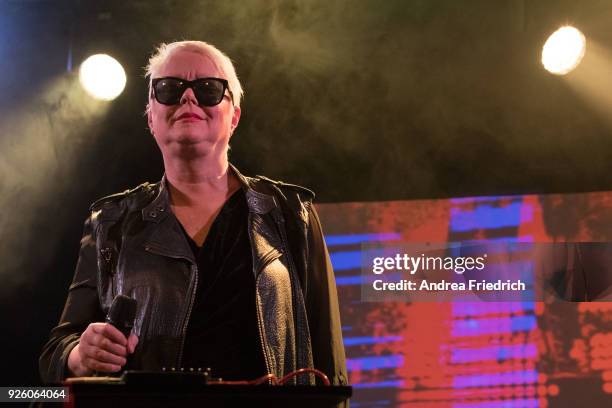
[40,166,347,385]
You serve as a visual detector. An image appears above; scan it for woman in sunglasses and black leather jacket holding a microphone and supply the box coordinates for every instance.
[40,41,347,384]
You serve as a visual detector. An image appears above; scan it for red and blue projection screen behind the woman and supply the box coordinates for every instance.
[317,192,612,408]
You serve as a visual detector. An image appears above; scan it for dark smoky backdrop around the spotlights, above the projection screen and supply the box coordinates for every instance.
[0,0,612,385]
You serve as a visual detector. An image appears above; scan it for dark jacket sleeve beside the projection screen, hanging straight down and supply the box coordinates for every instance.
[306,206,348,385]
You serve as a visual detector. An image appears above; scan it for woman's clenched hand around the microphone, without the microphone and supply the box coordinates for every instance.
[68,323,138,377]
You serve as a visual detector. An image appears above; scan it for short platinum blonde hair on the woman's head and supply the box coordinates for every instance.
[146,41,244,111]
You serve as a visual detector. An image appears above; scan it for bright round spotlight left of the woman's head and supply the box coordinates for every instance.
[79,54,126,101]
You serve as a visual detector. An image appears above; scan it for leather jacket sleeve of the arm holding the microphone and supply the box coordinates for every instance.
[39,217,104,383]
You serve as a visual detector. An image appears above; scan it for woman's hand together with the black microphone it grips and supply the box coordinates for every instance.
[68,295,138,377]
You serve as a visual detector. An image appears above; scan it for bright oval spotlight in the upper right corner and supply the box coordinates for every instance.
[542,26,586,75]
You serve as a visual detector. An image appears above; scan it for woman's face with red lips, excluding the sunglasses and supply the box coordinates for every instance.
[148,51,240,159]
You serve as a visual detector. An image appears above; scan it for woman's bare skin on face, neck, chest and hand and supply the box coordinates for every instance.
[68,50,240,376]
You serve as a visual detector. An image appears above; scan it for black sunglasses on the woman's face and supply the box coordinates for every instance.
[151,77,234,106]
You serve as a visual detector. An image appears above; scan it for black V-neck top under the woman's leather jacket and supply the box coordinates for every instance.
[182,189,266,380]
